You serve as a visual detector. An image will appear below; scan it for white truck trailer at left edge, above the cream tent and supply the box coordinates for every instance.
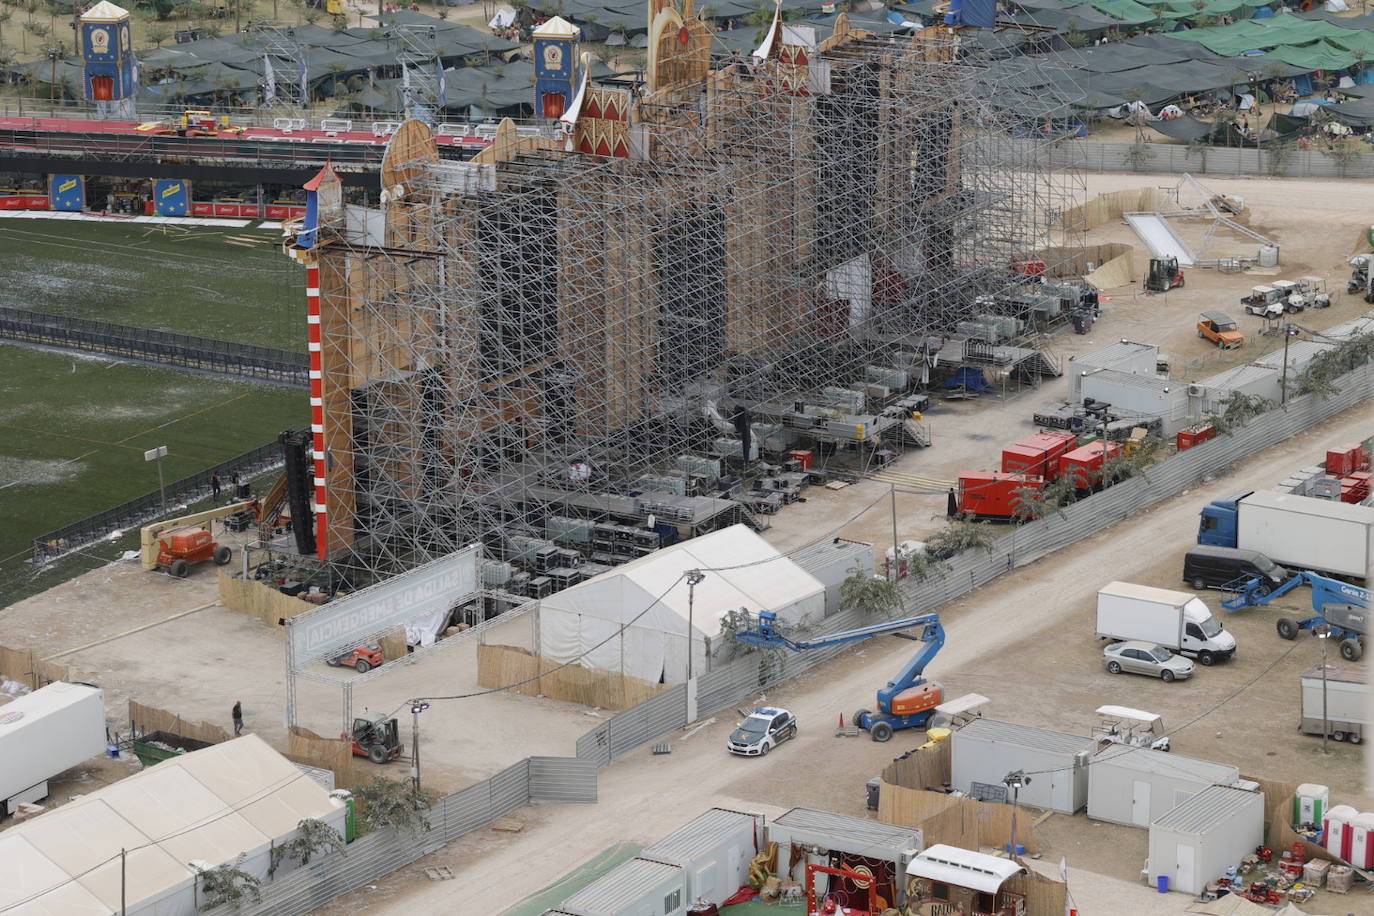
[0,681,106,817]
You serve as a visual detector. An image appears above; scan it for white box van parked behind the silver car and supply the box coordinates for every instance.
[1098,582,1235,665]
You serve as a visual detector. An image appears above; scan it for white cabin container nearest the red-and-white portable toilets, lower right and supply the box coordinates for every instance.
[1149,786,1264,894]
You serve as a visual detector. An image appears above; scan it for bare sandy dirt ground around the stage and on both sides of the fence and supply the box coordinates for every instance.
[0,176,1374,913]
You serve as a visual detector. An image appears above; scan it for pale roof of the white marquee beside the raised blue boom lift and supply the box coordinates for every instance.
[540,525,826,636]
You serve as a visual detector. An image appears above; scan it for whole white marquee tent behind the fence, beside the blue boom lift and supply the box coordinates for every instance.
[539,525,826,684]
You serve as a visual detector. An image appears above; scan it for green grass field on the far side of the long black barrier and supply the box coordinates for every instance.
[0,220,306,350]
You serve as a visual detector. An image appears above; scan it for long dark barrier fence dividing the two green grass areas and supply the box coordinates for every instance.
[0,306,311,389]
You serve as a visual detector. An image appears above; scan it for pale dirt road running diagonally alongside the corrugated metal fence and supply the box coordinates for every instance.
[322,390,1374,913]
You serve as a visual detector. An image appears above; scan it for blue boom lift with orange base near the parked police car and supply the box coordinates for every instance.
[735,611,944,742]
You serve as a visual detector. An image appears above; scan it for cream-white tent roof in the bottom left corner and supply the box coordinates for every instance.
[0,735,339,916]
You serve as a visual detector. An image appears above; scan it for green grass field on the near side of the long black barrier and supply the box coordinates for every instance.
[0,343,309,607]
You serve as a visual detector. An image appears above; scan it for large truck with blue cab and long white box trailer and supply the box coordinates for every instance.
[1198,490,1374,580]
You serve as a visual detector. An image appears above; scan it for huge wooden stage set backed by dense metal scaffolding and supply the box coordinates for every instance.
[289,17,1079,577]
